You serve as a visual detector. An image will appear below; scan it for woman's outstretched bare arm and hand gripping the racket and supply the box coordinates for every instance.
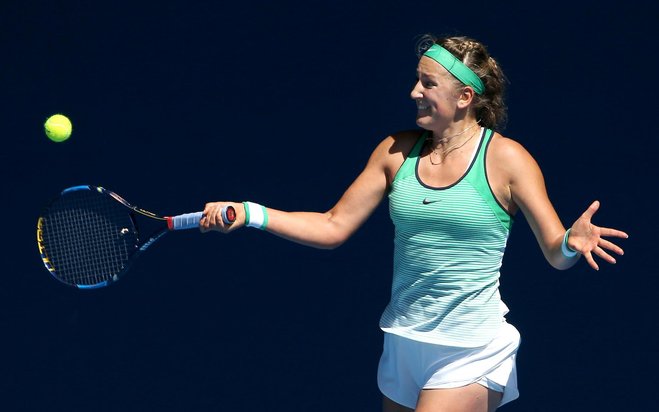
[200,137,400,249]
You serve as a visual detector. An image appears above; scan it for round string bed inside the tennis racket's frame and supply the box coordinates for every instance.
[42,190,137,286]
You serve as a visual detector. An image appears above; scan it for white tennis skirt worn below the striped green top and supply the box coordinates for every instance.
[378,322,520,409]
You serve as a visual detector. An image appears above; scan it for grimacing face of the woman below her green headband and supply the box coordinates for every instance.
[410,56,459,130]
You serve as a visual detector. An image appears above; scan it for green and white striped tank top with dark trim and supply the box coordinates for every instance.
[380,129,513,347]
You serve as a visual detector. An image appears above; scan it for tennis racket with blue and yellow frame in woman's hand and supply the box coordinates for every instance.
[37,185,236,289]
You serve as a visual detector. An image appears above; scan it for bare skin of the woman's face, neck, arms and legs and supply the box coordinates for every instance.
[200,57,628,412]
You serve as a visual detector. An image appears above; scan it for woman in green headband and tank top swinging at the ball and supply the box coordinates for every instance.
[200,36,627,412]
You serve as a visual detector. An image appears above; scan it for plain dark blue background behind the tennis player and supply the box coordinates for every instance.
[0,0,659,412]
